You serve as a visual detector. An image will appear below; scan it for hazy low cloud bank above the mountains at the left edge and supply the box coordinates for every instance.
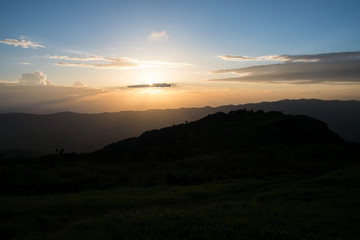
[0,85,107,113]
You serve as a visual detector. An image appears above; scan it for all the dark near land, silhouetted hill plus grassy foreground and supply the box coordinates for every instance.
[0,110,360,239]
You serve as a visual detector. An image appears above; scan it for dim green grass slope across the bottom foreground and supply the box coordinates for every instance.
[0,164,360,240]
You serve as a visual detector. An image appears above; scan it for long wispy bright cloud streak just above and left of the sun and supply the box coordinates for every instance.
[49,55,190,69]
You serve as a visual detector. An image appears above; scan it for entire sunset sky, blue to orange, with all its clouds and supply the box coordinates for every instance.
[0,0,360,113]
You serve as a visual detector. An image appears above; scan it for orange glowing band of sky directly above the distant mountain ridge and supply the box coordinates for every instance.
[0,82,360,113]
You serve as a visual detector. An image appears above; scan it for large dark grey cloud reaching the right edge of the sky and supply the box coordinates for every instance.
[211,52,360,84]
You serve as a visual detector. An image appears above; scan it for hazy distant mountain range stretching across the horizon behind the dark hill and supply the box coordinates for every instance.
[0,99,360,155]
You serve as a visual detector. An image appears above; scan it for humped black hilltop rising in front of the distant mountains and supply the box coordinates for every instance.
[97,109,343,161]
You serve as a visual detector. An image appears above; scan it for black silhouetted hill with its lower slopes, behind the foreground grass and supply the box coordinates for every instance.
[0,110,360,194]
